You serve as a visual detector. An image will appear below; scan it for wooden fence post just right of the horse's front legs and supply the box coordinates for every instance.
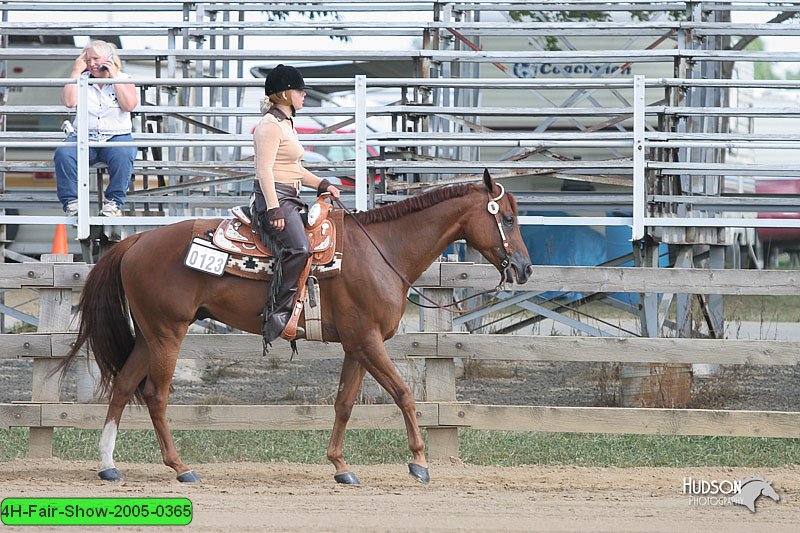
[422,289,458,461]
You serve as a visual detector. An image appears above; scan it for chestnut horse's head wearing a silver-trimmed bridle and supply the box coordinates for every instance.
[464,170,531,284]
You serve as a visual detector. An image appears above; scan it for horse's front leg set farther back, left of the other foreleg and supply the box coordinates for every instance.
[328,353,366,485]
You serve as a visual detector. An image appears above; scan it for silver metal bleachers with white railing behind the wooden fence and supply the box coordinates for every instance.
[0,0,800,336]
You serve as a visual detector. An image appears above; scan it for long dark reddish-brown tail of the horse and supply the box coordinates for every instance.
[58,234,142,401]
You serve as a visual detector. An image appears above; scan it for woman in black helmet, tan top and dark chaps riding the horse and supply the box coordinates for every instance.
[251,65,339,345]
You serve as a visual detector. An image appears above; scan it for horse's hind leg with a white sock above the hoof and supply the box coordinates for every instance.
[97,340,148,481]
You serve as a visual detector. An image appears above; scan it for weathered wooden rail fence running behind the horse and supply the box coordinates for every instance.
[0,256,800,460]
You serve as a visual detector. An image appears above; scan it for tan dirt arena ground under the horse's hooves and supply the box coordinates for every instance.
[0,459,800,533]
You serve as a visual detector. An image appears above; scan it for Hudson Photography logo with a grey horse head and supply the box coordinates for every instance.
[683,476,781,513]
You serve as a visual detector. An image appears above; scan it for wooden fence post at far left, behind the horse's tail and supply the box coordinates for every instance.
[28,254,72,459]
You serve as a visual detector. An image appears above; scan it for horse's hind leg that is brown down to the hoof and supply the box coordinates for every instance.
[144,338,200,482]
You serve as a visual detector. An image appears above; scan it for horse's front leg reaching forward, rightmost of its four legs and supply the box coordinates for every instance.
[346,338,430,483]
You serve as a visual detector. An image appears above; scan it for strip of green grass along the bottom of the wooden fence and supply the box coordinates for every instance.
[0,428,800,468]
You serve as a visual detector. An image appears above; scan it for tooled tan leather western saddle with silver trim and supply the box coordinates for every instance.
[192,194,344,280]
